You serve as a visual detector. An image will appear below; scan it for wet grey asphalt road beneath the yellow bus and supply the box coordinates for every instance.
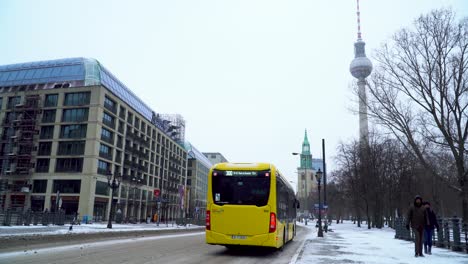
[0,226,308,264]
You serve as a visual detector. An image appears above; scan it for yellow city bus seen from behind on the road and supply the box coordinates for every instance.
[206,163,299,248]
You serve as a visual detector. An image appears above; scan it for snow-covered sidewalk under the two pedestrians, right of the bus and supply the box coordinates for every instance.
[291,222,468,264]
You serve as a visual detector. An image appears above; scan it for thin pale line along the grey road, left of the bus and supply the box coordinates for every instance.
[0,232,205,259]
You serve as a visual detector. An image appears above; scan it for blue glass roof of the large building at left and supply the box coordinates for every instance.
[0,58,177,141]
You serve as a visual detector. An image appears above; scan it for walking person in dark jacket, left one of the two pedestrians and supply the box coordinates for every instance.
[406,195,427,257]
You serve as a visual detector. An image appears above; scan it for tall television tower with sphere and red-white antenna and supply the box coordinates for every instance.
[349,0,372,146]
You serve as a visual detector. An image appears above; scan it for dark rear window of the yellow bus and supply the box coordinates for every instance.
[212,170,271,206]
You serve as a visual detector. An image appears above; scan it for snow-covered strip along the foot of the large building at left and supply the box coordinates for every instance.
[0,223,200,238]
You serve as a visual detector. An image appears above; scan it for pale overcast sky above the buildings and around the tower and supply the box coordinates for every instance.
[0,0,468,189]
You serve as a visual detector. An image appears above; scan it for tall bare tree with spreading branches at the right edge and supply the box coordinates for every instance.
[368,9,468,222]
